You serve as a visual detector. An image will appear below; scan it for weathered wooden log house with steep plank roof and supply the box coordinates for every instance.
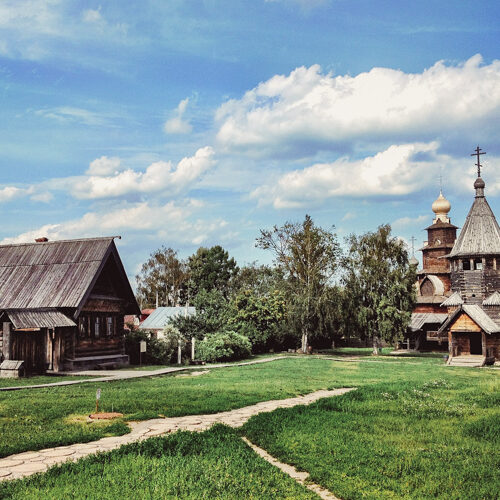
[0,237,140,374]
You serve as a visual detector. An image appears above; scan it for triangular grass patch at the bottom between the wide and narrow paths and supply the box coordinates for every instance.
[0,425,317,500]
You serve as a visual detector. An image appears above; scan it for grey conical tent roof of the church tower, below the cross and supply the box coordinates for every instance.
[448,185,500,257]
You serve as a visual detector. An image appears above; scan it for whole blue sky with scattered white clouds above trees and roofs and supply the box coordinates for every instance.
[0,0,500,278]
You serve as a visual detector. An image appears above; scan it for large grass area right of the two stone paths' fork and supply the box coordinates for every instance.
[243,367,500,499]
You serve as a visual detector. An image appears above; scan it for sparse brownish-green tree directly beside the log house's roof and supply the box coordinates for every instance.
[135,246,188,308]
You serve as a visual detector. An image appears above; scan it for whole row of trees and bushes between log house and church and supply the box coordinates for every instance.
[136,215,416,353]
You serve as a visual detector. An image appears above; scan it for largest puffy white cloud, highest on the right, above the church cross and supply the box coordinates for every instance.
[216,55,500,155]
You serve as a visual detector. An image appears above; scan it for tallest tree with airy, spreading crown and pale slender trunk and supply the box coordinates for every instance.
[257,215,341,352]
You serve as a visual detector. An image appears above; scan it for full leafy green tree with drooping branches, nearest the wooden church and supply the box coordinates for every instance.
[344,224,416,354]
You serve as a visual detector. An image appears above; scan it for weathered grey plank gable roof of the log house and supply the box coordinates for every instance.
[0,237,138,314]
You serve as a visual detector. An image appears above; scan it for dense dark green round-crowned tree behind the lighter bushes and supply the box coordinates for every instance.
[188,245,238,300]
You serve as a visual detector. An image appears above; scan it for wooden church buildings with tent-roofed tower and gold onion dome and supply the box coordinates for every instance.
[411,147,500,366]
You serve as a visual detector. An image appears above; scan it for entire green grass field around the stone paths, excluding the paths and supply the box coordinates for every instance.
[0,356,500,499]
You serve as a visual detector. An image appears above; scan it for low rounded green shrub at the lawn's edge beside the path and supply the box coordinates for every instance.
[197,330,252,362]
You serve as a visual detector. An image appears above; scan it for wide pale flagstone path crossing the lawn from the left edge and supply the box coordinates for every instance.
[0,386,355,480]
